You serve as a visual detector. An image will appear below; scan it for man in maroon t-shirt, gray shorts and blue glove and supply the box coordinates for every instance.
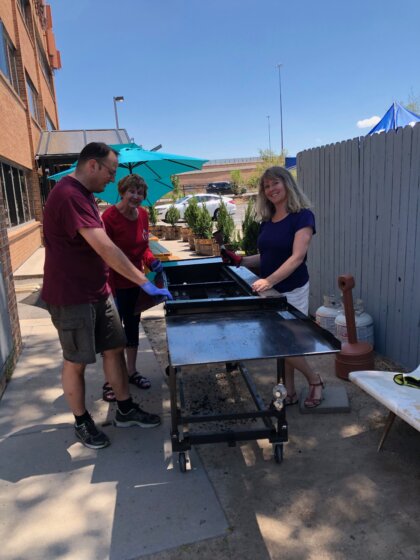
[42,142,172,449]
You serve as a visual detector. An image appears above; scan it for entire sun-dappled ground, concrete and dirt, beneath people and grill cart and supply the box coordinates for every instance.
[4,242,420,560]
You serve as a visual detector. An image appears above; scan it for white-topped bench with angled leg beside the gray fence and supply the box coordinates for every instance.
[349,366,420,451]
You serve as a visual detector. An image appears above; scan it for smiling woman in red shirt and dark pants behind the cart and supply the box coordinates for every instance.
[102,174,162,402]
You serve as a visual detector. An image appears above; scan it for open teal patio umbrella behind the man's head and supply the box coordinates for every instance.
[48,144,208,206]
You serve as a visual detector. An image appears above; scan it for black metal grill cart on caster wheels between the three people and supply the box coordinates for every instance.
[159,258,340,472]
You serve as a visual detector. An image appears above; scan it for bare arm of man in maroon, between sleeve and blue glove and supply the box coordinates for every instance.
[78,228,148,286]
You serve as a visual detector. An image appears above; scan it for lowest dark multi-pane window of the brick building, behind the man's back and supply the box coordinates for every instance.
[0,162,32,227]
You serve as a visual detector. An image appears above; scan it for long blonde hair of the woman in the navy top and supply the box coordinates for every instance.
[255,166,312,222]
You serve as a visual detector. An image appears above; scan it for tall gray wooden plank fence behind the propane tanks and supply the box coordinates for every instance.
[297,125,420,368]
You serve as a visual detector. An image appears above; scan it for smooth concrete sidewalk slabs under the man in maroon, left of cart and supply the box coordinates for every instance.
[0,244,227,560]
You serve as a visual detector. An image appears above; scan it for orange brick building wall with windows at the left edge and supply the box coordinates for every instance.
[0,0,61,384]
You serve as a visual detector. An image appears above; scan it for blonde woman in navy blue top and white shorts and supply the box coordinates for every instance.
[223,167,324,408]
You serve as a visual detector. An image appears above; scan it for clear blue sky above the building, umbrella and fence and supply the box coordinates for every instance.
[48,0,420,159]
